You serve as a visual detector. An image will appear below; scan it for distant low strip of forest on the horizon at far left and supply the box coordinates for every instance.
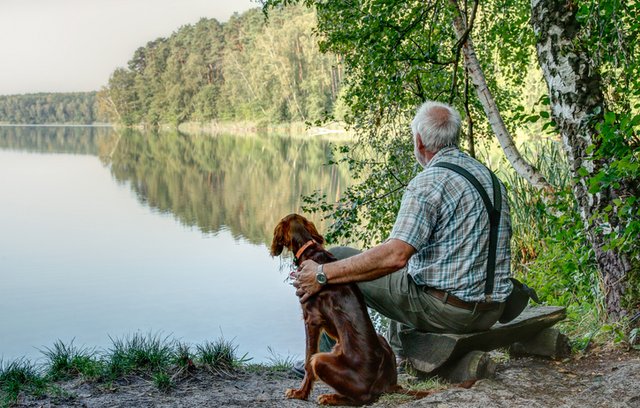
[0,92,106,125]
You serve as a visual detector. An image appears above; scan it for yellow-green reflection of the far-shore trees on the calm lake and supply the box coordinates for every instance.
[0,127,349,244]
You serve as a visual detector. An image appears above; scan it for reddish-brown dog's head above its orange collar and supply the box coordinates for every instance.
[271,214,324,256]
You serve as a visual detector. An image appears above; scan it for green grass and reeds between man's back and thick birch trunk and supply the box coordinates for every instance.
[497,139,605,328]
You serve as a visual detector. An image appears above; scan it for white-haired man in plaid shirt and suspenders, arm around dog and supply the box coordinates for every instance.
[294,101,512,361]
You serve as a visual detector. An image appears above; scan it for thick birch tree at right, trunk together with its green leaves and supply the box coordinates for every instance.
[531,0,640,320]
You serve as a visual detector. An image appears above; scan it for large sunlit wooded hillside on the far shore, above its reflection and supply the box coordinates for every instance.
[98,6,341,125]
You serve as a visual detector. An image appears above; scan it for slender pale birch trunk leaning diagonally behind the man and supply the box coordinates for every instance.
[451,0,553,191]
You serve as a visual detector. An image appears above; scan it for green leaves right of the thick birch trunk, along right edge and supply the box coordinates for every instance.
[576,0,640,311]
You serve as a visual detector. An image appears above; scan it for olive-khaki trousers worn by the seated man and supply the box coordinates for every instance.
[329,247,504,357]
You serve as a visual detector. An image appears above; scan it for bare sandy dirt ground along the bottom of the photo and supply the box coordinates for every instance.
[18,351,640,408]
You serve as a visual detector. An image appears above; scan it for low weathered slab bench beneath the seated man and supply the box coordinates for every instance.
[400,306,569,381]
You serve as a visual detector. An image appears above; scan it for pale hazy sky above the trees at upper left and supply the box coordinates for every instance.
[0,0,259,95]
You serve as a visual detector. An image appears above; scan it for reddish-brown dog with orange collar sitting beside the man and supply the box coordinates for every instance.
[271,214,431,405]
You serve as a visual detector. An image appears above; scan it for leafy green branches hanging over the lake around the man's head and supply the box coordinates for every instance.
[265,0,532,246]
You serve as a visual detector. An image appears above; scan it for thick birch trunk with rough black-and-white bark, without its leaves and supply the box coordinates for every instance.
[531,0,631,320]
